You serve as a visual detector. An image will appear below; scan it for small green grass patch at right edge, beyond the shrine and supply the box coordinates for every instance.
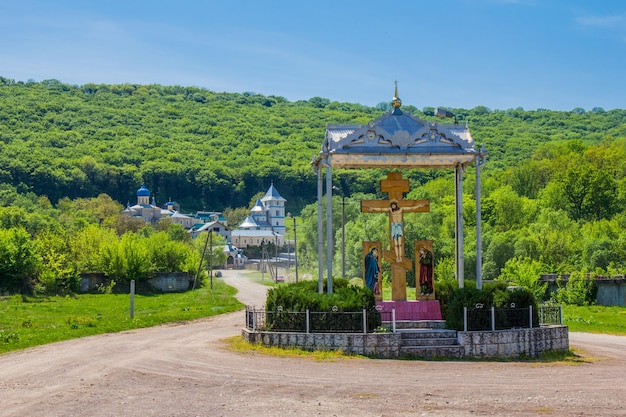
[563,305,626,335]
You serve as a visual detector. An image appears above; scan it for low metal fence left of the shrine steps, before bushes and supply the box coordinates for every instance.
[246,306,381,333]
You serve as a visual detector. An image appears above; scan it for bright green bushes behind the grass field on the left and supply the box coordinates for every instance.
[0,224,225,295]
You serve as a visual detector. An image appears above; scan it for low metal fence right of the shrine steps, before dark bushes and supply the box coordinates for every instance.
[463,303,563,332]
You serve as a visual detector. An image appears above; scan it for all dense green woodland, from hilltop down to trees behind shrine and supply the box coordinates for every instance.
[0,77,626,291]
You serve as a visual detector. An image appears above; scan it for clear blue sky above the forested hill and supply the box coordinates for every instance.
[0,0,626,110]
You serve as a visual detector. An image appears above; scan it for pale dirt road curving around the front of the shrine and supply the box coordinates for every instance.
[0,271,626,416]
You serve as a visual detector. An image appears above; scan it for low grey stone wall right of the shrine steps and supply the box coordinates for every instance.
[457,326,569,358]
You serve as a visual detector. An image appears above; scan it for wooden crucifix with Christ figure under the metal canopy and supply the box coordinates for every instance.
[361,172,430,301]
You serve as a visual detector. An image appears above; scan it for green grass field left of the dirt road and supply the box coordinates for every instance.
[0,280,243,353]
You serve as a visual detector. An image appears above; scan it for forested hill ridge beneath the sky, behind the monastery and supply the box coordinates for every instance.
[0,77,626,212]
